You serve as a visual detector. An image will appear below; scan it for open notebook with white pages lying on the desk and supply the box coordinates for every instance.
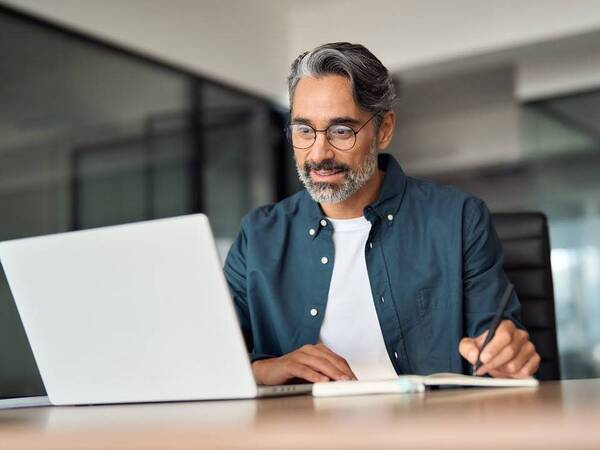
[313,373,539,397]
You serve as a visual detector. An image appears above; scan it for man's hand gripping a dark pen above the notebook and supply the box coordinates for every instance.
[458,320,541,378]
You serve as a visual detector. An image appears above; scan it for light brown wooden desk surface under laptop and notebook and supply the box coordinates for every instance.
[0,379,600,450]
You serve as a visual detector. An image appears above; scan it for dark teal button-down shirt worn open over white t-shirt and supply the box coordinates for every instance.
[224,154,521,374]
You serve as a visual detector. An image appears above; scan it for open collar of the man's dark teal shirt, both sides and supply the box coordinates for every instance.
[300,153,406,239]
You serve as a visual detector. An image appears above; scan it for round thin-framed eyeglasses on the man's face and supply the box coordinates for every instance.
[286,111,380,152]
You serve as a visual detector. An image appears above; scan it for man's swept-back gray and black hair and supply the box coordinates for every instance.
[288,42,396,128]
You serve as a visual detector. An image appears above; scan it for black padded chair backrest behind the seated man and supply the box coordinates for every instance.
[492,212,560,381]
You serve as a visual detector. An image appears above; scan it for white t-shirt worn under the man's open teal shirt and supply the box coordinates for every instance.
[319,217,397,380]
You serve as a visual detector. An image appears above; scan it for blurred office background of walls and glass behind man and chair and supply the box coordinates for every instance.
[0,0,600,394]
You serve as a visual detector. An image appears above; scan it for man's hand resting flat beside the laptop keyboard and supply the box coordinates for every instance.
[252,344,356,384]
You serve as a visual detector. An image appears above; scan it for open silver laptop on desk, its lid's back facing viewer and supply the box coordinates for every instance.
[0,214,311,405]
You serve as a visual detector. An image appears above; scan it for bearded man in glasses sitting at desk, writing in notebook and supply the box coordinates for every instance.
[224,43,540,384]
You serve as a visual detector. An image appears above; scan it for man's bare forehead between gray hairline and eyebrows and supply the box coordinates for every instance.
[292,75,361,121]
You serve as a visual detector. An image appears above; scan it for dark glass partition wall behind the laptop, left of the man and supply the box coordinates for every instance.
[0,7,294,398]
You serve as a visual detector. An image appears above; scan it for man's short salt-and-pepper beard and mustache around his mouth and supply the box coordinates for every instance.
[296,143,377,203]
